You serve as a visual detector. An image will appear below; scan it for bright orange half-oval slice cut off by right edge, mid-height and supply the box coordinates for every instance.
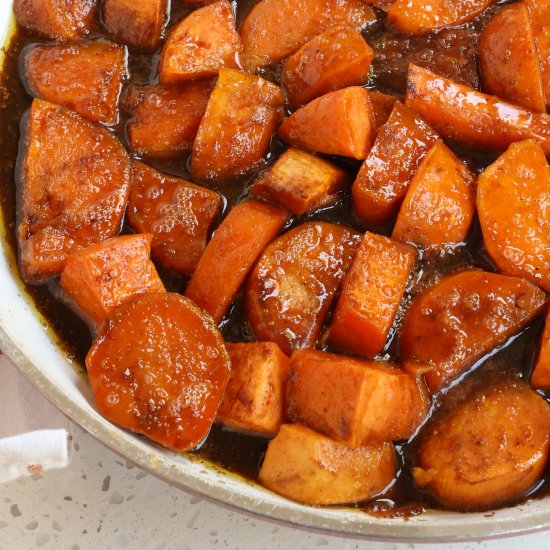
[477,140,550,292]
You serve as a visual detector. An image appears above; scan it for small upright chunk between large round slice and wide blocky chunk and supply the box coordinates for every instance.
[218,342,288,437]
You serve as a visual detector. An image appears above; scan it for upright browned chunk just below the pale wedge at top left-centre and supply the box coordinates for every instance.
[191,69,284,180]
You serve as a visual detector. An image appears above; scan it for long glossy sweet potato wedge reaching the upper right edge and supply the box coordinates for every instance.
[405,65,550,160]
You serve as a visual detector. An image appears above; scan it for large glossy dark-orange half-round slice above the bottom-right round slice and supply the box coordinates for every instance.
[399,270,545,392]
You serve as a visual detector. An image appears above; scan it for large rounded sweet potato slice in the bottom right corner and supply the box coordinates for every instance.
[413,379,550,511]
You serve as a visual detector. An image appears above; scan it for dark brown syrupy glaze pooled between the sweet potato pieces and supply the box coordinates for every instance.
[0,0,550,519]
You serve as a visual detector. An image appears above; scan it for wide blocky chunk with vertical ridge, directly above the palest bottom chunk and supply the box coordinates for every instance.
[287,350,428,448]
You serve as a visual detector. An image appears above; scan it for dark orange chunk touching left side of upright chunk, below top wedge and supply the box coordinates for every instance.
[124,81,213,159]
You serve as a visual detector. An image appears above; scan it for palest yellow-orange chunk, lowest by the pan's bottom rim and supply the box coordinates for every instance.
[258,424,397,505]
